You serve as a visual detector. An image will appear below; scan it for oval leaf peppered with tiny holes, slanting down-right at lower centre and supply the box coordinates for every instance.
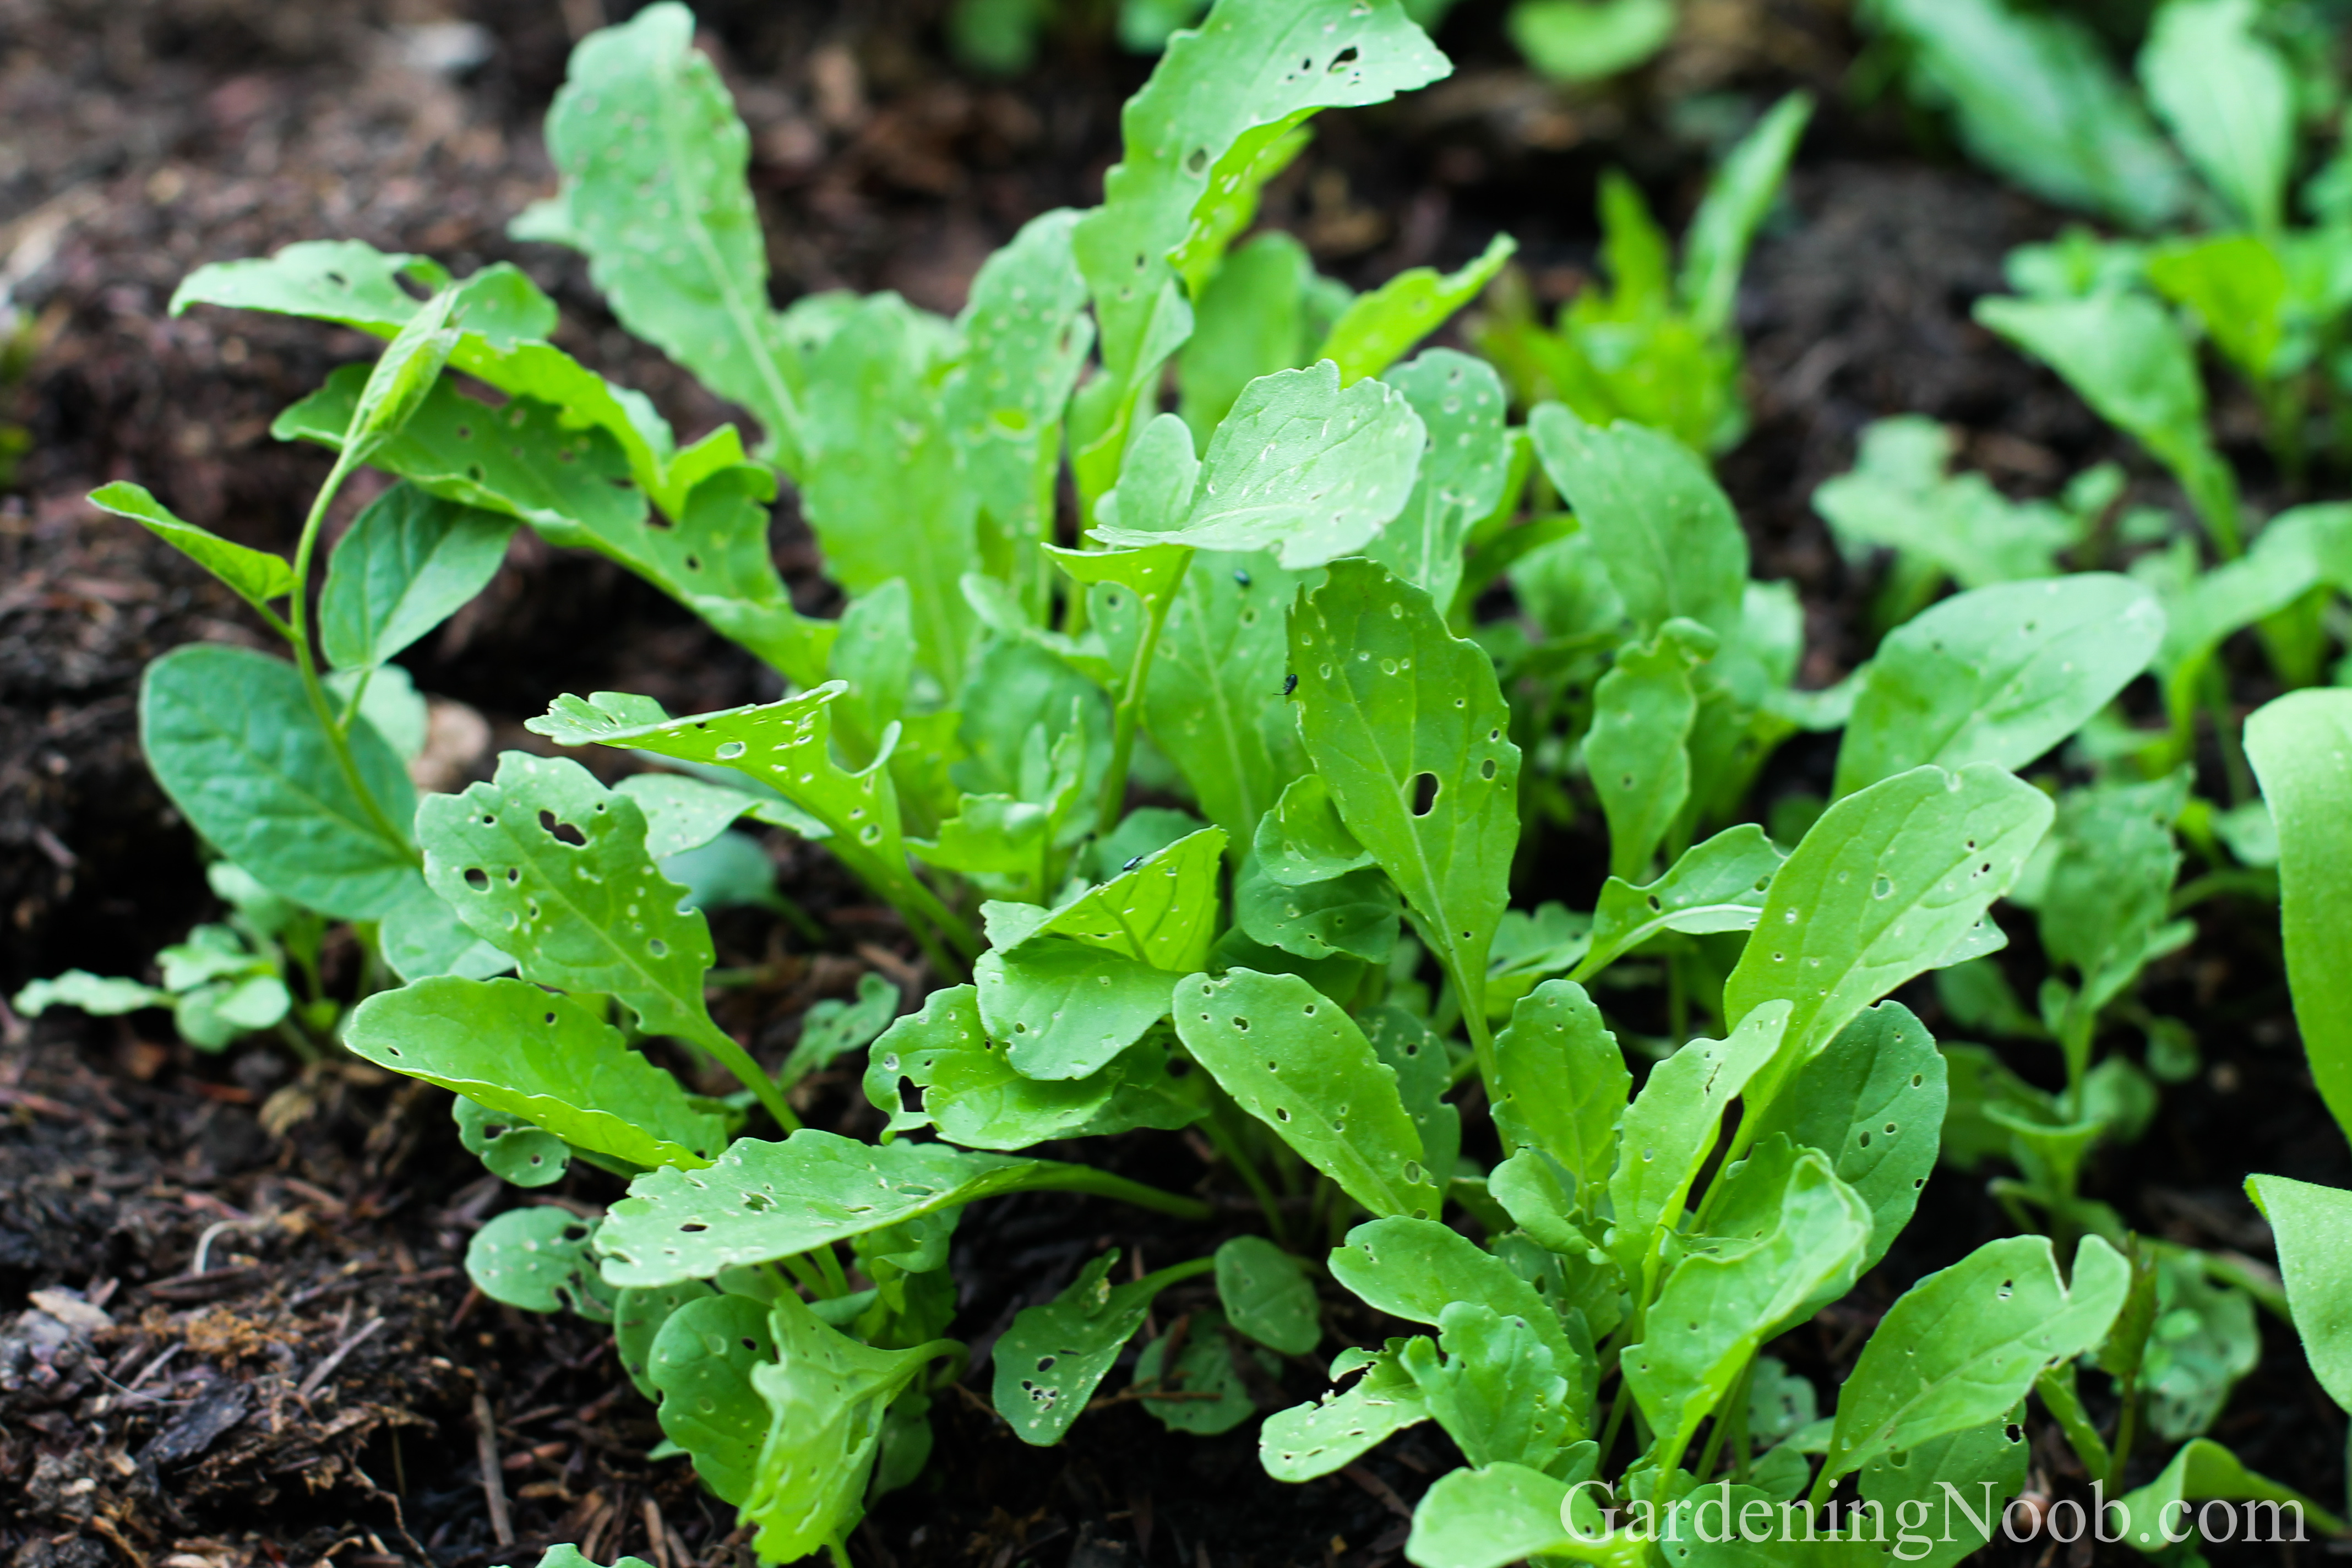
[1176,968,1444,1216]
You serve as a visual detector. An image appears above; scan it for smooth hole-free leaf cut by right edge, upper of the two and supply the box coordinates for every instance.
[2246,691,2352,1147]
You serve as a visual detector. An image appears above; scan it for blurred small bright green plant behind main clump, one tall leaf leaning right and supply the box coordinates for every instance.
[1472,92,1814,451]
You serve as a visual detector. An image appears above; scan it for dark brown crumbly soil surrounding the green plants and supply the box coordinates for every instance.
[0,0,2352,1568]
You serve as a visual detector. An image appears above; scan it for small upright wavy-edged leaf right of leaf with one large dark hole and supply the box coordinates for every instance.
[1585,618,1717,879]
